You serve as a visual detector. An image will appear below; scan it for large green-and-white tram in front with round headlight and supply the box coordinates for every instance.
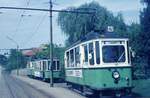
[65,32,132,96]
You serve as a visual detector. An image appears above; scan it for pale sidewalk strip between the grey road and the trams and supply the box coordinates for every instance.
[13,75,85,98]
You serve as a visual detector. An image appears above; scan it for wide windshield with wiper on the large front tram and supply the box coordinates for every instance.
[102,45,125,63]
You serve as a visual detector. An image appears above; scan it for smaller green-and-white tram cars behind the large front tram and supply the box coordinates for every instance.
[28,58,63,81]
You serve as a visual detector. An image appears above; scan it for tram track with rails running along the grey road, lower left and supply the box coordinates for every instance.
[3,74,54,98]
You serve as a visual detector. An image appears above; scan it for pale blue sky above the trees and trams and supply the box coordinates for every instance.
[0,0,142,49]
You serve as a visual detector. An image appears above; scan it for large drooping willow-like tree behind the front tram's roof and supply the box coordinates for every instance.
[58,2,126,44]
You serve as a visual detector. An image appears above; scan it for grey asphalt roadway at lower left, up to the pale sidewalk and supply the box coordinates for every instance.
[0,72,52,98]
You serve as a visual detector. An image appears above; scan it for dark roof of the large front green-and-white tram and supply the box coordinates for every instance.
[68,31,128,48]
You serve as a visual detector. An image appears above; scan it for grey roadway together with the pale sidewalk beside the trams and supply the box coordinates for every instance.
[0,68,146,98]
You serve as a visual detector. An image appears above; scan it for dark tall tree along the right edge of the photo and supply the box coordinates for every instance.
[138,0,150,73]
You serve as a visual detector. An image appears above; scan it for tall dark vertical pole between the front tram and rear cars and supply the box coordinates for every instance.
[49,0,53,87]
